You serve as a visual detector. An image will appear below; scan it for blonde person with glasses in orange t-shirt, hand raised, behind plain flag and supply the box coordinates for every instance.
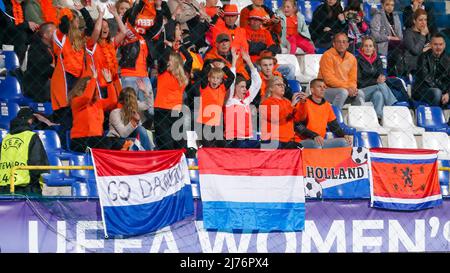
[259,76,306,149]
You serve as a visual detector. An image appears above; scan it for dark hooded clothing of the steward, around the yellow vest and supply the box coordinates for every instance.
[2,118,49,187]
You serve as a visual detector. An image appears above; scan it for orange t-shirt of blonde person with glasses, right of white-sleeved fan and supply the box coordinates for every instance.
[259,97,296,142]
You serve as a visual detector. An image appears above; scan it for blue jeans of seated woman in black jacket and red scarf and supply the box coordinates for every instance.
[362,83,397,118]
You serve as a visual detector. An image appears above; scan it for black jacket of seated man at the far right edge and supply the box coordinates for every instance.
[413,49,450,94]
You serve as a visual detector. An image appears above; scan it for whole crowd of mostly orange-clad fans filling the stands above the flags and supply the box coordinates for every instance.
[0,0,450,152]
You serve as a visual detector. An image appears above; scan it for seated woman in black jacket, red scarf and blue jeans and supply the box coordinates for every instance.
[356,36,397,119]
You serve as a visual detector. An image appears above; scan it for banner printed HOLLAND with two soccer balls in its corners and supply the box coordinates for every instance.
[303,147,370,199]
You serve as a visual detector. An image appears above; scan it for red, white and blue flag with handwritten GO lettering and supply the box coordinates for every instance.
[91,149,194,237]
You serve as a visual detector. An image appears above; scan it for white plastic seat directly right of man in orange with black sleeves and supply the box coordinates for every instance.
[348,105,389,135]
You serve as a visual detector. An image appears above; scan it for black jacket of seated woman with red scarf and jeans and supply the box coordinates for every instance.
[356,53,383,88]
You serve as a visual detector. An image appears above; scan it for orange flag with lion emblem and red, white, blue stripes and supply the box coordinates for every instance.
[369,148,442,210]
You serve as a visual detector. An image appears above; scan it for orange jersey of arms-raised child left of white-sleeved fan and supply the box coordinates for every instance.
[197,84,227,126]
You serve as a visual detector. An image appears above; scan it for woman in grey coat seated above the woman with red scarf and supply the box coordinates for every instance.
[370,0,403,56]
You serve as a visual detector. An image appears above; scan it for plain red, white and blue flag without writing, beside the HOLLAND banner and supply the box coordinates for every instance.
[198,148,305,232]
